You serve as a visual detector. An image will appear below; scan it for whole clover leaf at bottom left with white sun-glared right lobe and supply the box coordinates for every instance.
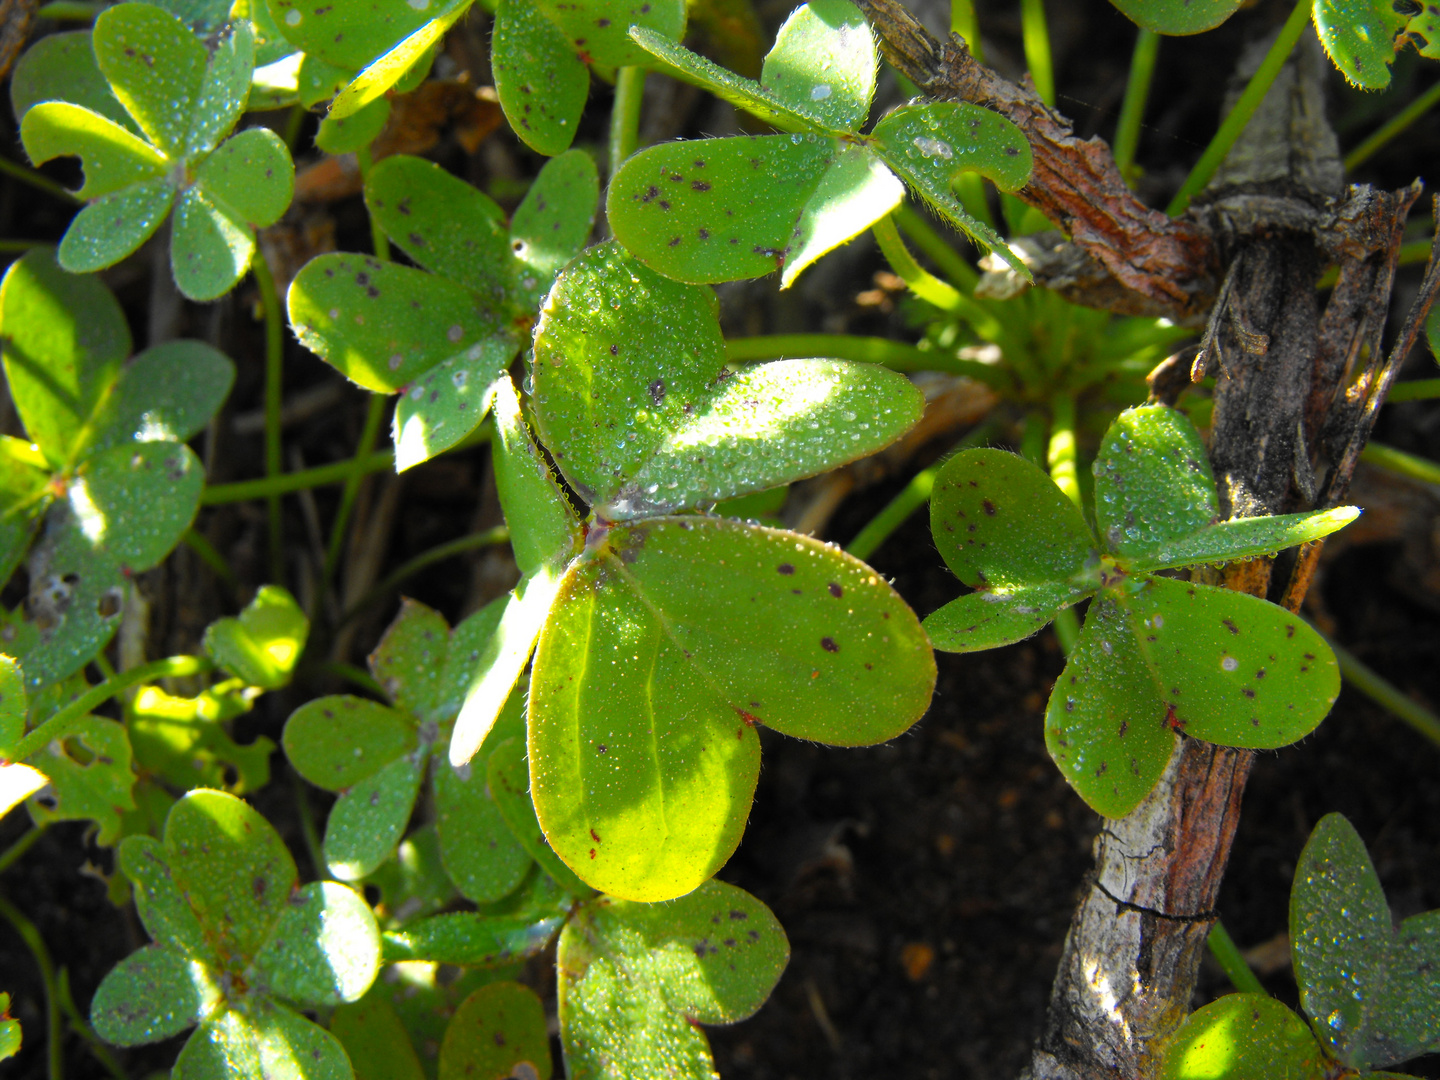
[91,789,380,1080]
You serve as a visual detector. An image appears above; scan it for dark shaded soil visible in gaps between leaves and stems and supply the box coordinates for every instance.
[0,0,1440,1080]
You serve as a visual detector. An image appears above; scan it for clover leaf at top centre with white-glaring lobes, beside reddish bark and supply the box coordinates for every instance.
[606,0,1031,288]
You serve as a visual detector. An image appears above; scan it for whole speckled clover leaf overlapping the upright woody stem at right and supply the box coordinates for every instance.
[924,406,1359,818]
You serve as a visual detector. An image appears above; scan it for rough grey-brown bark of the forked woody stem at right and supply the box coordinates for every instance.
[860,0,1437,1080]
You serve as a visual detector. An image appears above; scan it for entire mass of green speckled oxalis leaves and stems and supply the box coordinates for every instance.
[0,0,1440,1080]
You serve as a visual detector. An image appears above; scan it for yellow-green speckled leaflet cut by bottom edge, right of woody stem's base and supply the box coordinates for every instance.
[1159,994,1329,1080]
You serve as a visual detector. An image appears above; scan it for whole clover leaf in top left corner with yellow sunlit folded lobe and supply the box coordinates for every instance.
[20,3,295,301]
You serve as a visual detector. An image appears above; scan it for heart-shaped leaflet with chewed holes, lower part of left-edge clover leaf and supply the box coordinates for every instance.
[10,442,204,690]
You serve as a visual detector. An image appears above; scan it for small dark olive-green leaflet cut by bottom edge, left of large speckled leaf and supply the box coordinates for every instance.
[439,982,552,1080]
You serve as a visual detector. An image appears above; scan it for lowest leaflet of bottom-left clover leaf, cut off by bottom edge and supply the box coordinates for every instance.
[170,996,354,1080]
